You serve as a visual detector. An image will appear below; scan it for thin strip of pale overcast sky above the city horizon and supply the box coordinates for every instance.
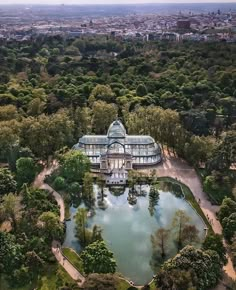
[0,0,236,5]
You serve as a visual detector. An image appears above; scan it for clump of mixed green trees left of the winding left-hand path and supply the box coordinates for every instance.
[0,185,64,287]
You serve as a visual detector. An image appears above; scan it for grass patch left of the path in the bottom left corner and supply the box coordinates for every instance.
[0,265,75,290]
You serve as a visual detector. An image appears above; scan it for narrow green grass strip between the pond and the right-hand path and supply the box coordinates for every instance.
[157,177,212,232]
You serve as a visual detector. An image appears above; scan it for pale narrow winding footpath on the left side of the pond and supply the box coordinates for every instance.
[34,162,85,286]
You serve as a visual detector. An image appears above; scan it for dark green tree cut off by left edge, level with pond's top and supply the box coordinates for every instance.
[0,168,16,195]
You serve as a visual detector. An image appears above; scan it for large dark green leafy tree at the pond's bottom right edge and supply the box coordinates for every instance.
[155,246,223,290]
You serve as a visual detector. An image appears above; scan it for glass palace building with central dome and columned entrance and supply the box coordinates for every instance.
[73,120,162,171]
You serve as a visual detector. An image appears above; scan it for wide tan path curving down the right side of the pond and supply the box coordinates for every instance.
[142,154,236,279]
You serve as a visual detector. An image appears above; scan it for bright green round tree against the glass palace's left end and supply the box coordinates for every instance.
[60,150,90,183]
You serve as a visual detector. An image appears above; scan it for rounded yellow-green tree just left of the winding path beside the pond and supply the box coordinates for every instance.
[38,212,64,241]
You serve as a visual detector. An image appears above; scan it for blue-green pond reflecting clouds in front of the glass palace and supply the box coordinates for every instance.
[63,182,205,285]
